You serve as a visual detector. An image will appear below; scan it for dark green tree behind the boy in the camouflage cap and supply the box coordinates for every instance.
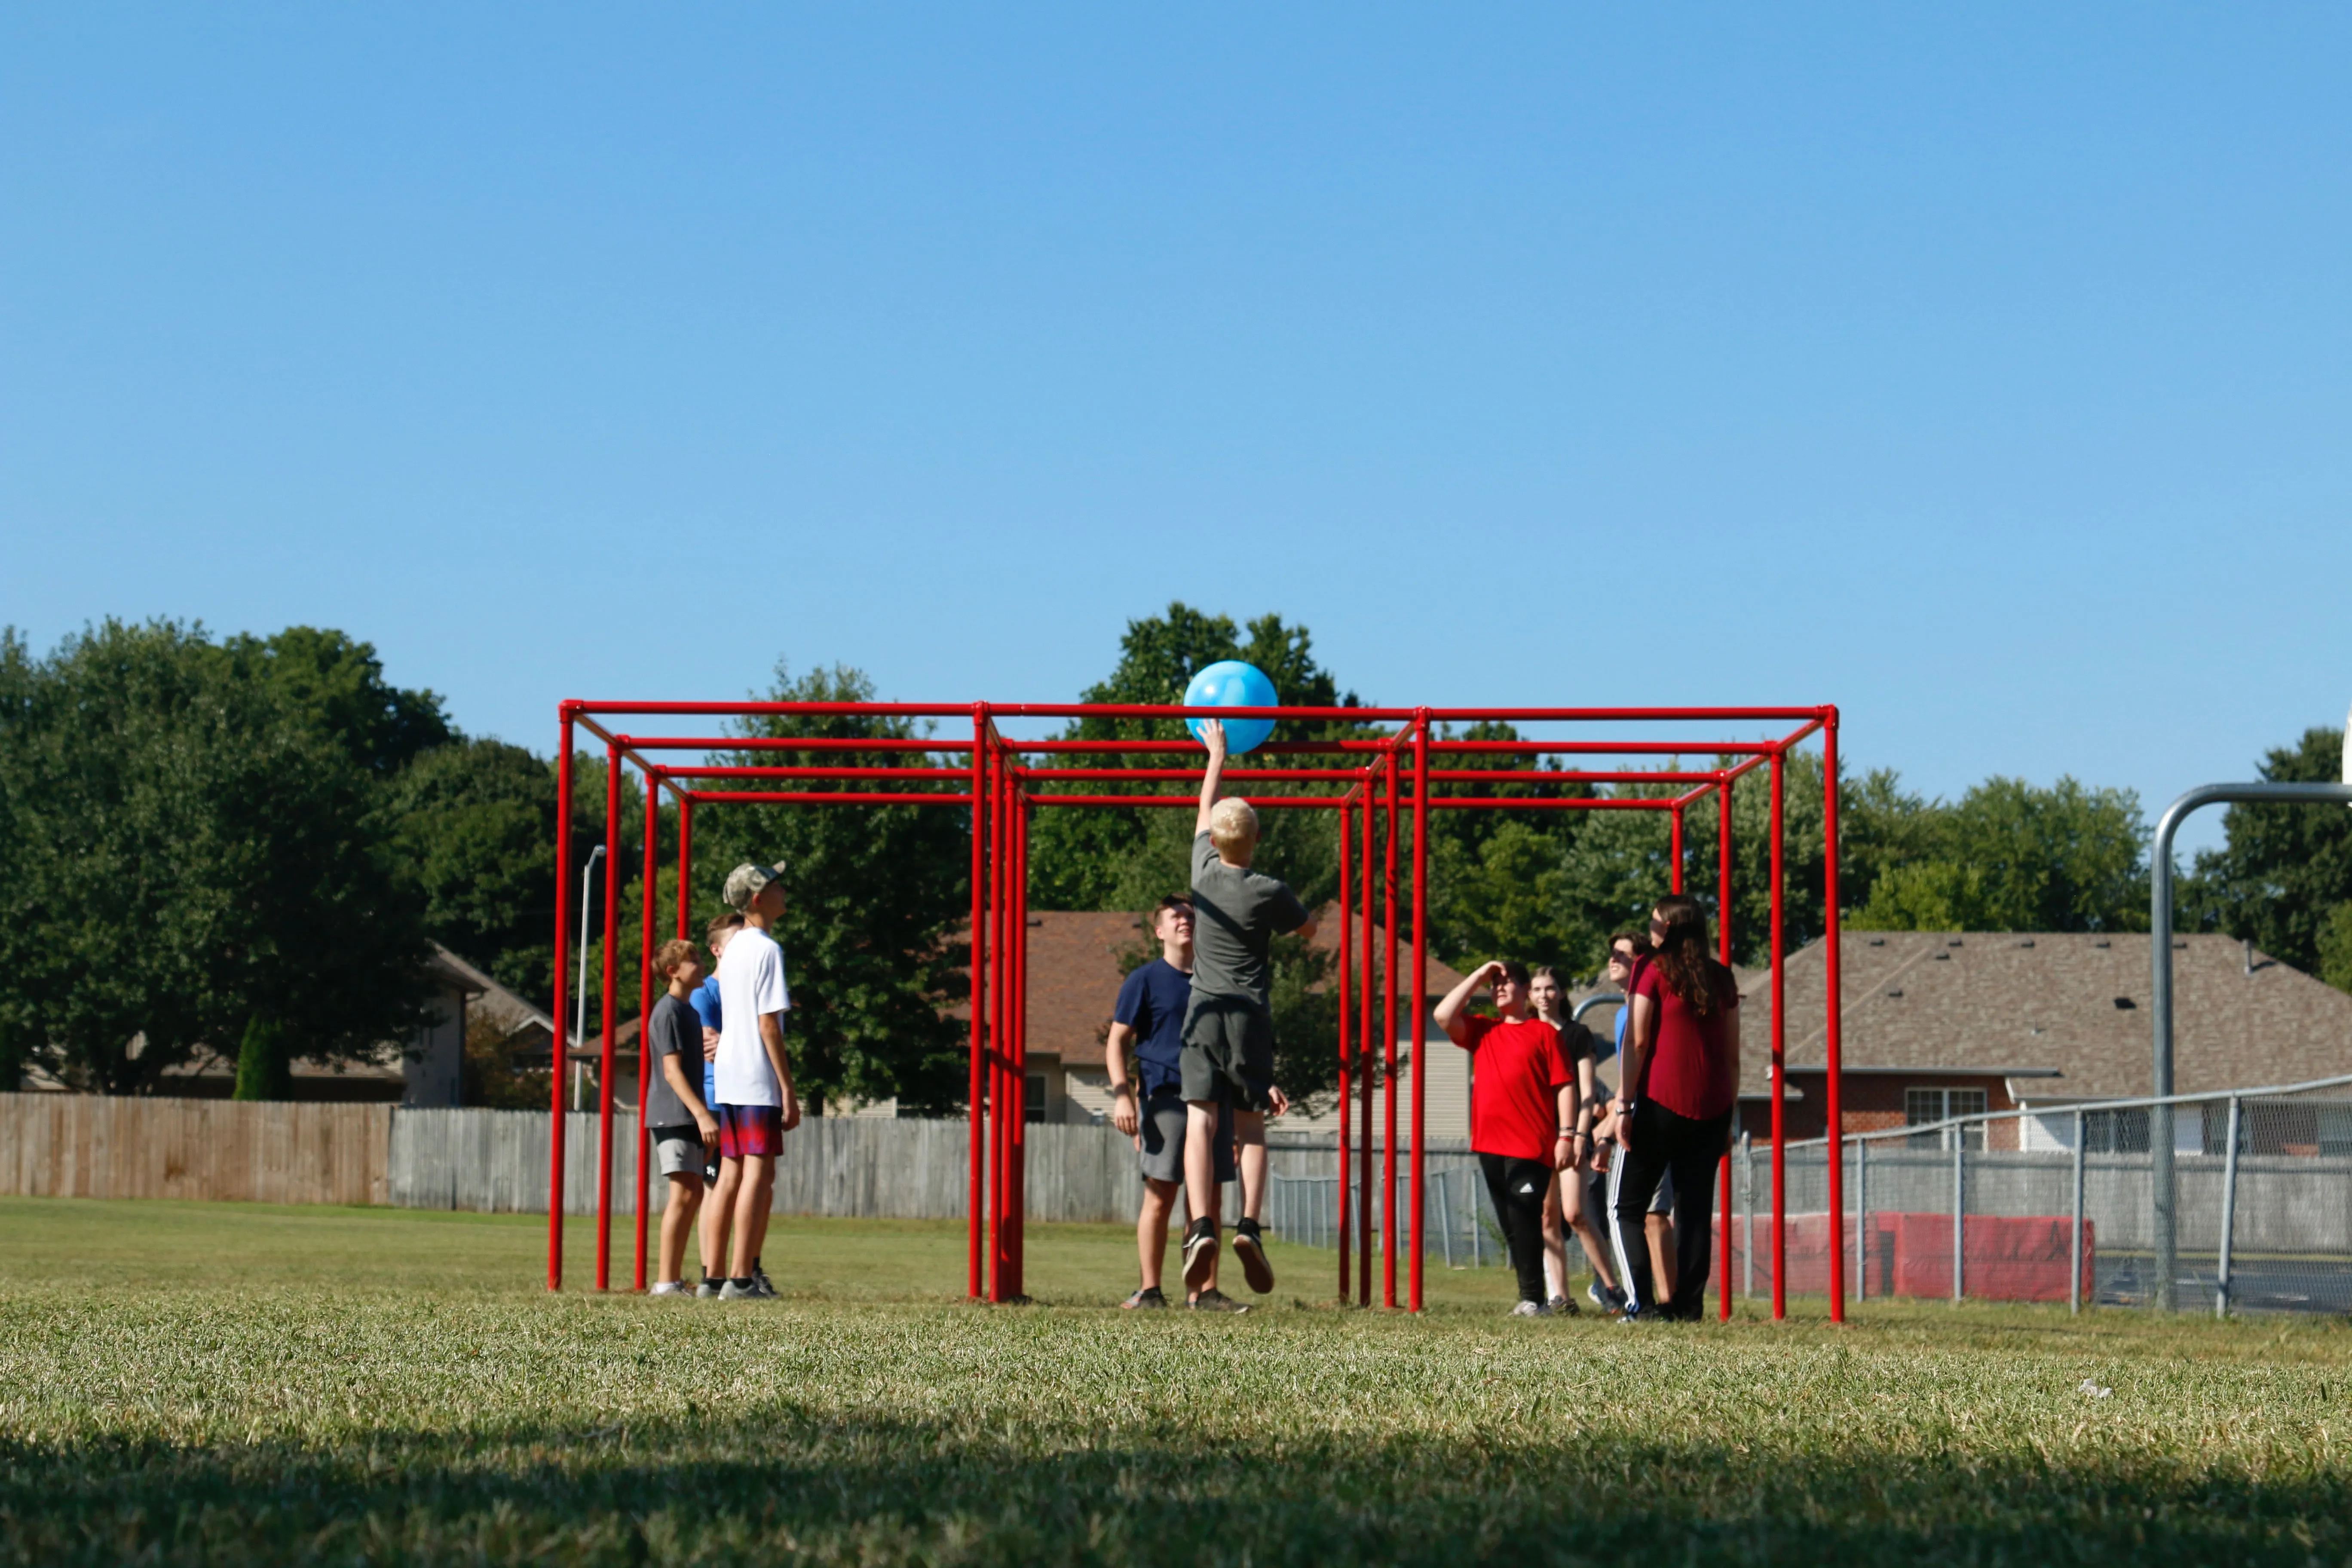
[694,663,971,1114]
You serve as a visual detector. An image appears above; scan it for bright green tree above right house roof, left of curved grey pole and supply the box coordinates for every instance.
[1853,778,2150,931]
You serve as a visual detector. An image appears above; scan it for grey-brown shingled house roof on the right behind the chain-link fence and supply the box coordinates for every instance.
[1740,931,2352,1102]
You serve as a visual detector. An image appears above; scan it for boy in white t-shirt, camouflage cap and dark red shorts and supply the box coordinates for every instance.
[713,863,799,1300]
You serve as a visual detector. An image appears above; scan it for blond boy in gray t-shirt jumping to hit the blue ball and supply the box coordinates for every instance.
[1178,720,1315,1295]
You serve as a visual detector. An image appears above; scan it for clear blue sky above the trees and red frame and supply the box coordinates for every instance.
[0,5,2352,846]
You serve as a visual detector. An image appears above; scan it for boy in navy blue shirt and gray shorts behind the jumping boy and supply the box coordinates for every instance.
[1103,898,1249,1312]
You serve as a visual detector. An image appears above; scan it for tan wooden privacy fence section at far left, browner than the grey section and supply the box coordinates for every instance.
[0,1093,390,1204]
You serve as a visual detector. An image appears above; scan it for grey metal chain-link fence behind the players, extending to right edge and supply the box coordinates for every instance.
[1268,1077,2352,1312]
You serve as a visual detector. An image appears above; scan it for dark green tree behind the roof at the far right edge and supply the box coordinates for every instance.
[2180,726,2352,990]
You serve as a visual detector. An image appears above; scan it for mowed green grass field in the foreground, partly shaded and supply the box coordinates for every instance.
[0,1199,2352,1566]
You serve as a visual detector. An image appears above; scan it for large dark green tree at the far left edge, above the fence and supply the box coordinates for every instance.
[0,621,426,1093]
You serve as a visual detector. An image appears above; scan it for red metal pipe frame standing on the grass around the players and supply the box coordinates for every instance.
[548,701,1844,1321]
